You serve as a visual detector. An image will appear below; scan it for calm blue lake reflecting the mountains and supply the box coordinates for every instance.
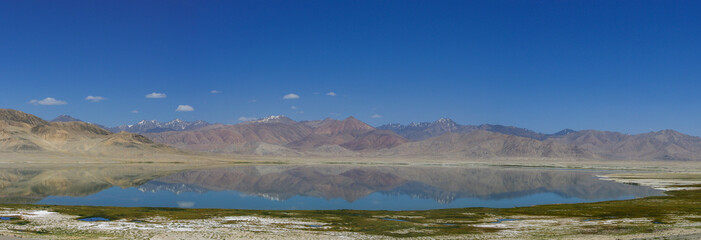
[17,166,661,210]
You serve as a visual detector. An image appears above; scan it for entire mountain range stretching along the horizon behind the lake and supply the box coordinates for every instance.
[0,110,701,161]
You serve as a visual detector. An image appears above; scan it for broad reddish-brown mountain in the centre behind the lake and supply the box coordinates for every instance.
[145,116,406,155]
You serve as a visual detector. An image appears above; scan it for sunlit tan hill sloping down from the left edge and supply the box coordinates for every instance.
[0,109,177,155]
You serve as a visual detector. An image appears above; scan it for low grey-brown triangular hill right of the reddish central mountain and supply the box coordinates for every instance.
[372,130,595,158]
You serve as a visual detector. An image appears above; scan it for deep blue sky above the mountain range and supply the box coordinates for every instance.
[0,0,701,135]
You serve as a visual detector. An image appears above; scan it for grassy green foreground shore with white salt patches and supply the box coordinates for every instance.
[0,168,701,239]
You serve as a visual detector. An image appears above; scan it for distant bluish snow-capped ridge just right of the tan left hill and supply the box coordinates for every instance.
[109,119,210,133]
